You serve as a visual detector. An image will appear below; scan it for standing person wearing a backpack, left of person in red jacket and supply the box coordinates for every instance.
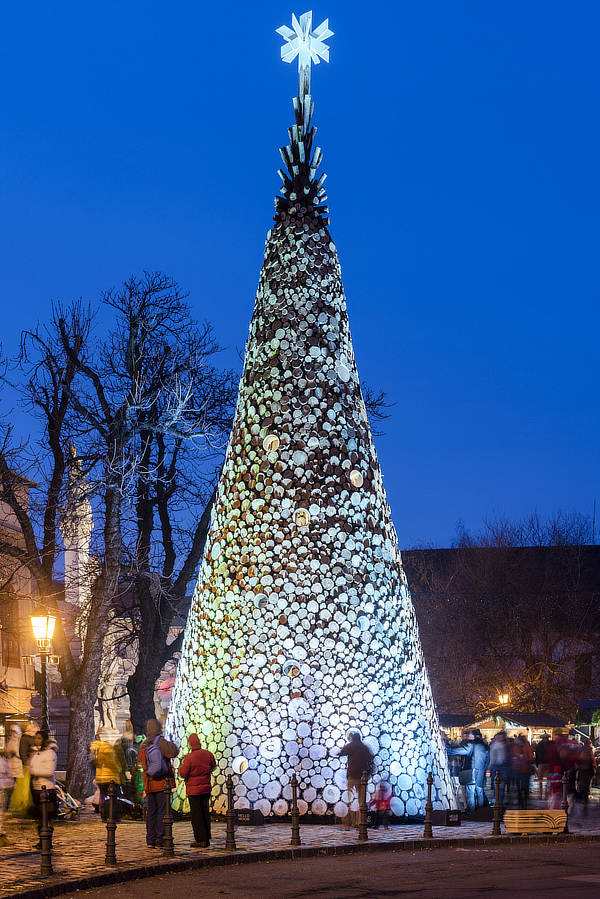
[138,718,179,849]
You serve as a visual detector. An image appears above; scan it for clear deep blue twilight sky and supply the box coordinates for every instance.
[0,0,600,545]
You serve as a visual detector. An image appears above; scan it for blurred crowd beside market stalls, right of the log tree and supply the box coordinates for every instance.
[446,728,596,817]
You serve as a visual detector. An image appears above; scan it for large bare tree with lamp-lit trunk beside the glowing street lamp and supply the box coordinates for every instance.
[0,273,234,795]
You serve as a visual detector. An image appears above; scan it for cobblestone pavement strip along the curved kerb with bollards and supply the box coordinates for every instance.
[0,813,600,897]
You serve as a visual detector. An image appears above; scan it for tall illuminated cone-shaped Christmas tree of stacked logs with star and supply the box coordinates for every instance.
[167,13,452,816]
